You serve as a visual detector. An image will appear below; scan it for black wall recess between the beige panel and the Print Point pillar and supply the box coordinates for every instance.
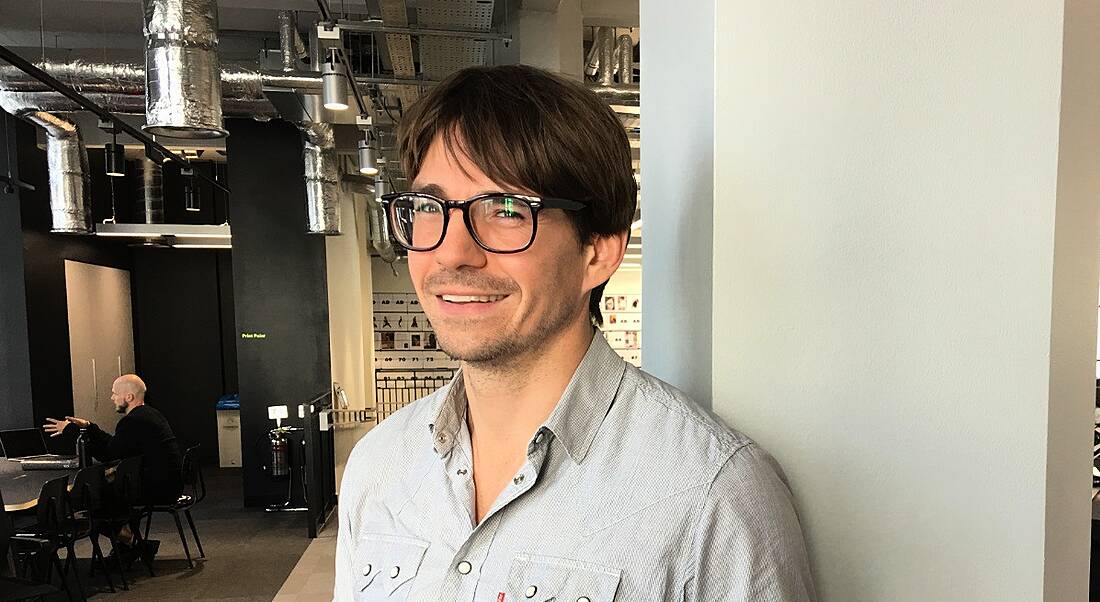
[132,249,235,463]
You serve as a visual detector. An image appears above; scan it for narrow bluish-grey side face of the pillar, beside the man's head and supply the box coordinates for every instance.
[640,0,715,406]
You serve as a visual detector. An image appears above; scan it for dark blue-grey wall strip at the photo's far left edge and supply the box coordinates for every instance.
[0,111,34,428]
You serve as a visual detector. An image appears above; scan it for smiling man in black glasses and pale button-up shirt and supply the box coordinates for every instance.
[336,66,815,602]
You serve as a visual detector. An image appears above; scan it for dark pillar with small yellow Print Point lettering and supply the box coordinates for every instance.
[227,120,330,505]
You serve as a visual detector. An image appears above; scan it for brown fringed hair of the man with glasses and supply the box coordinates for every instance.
[397,65,638,326]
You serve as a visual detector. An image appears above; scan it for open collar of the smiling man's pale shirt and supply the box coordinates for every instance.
[428,331,626,463]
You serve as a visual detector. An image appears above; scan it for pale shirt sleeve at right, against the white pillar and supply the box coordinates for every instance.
[684,444,816,602]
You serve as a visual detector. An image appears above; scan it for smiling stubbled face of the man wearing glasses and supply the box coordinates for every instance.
[409,138,598,366]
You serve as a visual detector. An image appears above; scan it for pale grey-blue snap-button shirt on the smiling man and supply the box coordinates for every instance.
[334,333,815,602]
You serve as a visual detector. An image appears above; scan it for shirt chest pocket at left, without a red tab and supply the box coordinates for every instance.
[354,534,428,602]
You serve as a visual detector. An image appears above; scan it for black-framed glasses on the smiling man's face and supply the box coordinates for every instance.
[382,193,587,253]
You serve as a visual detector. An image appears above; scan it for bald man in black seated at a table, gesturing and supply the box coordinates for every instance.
[43,374,183,504]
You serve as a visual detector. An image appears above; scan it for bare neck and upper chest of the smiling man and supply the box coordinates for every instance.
[462,315,594,449]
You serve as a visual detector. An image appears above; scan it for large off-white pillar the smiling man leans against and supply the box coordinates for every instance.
[641,0,1100,602]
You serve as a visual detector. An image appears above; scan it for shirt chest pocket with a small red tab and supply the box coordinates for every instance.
[506,554,623,602]
